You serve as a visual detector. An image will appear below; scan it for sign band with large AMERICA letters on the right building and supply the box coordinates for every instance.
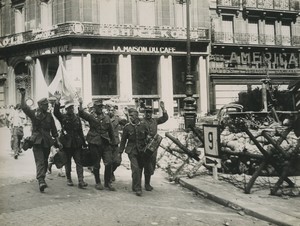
[210,52,300,73]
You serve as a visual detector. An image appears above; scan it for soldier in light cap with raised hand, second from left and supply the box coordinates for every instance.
[54,93,87,188]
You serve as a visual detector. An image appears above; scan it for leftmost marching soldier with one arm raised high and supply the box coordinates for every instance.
[20,89,62,192]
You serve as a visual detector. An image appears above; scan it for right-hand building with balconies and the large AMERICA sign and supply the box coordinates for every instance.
[209,0,300,110]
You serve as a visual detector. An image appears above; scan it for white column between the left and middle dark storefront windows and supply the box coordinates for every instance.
[117,55,132,102]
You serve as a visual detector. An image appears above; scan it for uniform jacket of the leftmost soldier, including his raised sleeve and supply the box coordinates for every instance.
[21,105,58,148]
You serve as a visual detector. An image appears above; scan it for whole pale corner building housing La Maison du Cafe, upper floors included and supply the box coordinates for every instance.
[0,0,210,122]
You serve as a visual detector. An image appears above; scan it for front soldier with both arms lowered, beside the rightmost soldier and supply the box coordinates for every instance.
[120,108,151,196]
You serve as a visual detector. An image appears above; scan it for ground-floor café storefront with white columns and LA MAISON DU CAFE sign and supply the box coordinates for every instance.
[3,39,209,128]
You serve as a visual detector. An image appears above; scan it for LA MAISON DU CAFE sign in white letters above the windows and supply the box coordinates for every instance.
[113,46,175,54]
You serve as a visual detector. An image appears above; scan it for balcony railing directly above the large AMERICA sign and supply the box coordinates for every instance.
[212,32,300,46]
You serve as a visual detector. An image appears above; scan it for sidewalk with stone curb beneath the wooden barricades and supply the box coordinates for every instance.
[179,175,300,226]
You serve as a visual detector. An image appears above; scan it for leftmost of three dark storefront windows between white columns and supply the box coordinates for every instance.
[92,55,118,95]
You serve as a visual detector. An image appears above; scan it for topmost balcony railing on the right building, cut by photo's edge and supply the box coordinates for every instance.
[217,0,300,11]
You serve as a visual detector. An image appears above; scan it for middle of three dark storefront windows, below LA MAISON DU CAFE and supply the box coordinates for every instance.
[131,56,159,95]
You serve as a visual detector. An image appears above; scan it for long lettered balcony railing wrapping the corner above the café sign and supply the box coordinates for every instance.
[0,22,210,48]
